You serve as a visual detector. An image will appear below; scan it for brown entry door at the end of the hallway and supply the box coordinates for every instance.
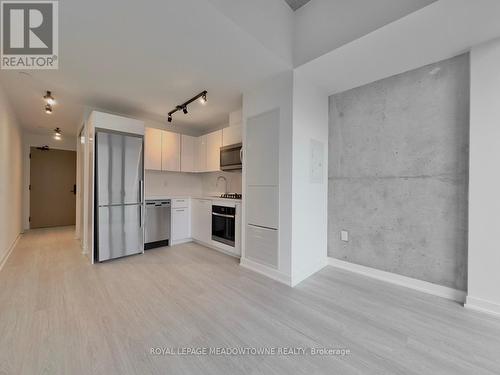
[30,147,76,229]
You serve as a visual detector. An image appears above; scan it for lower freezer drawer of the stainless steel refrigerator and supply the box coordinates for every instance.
[97,204,144,262]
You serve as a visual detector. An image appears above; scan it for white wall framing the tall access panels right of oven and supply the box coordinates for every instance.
[242,71,293,281]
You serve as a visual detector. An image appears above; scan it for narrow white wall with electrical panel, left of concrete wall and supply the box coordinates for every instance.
[292,72,328,285]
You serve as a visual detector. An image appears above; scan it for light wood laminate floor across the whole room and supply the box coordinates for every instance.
[0,228,500,375]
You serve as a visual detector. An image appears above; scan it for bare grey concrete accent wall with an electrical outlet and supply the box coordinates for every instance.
[328,54,469,290]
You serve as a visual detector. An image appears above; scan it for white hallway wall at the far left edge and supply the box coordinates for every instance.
[0,87,23,268]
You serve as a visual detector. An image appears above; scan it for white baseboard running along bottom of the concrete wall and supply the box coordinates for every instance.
[328,257,466,303]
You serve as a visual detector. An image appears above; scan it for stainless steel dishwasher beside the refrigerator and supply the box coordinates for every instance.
[144,199,171,250]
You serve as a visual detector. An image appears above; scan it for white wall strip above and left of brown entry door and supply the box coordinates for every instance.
[23,131,77,230]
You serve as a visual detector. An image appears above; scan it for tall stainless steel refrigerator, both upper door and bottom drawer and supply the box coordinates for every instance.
[94,130,144,262]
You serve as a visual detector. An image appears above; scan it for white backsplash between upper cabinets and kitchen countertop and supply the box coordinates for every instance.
[144,171,241,196]
